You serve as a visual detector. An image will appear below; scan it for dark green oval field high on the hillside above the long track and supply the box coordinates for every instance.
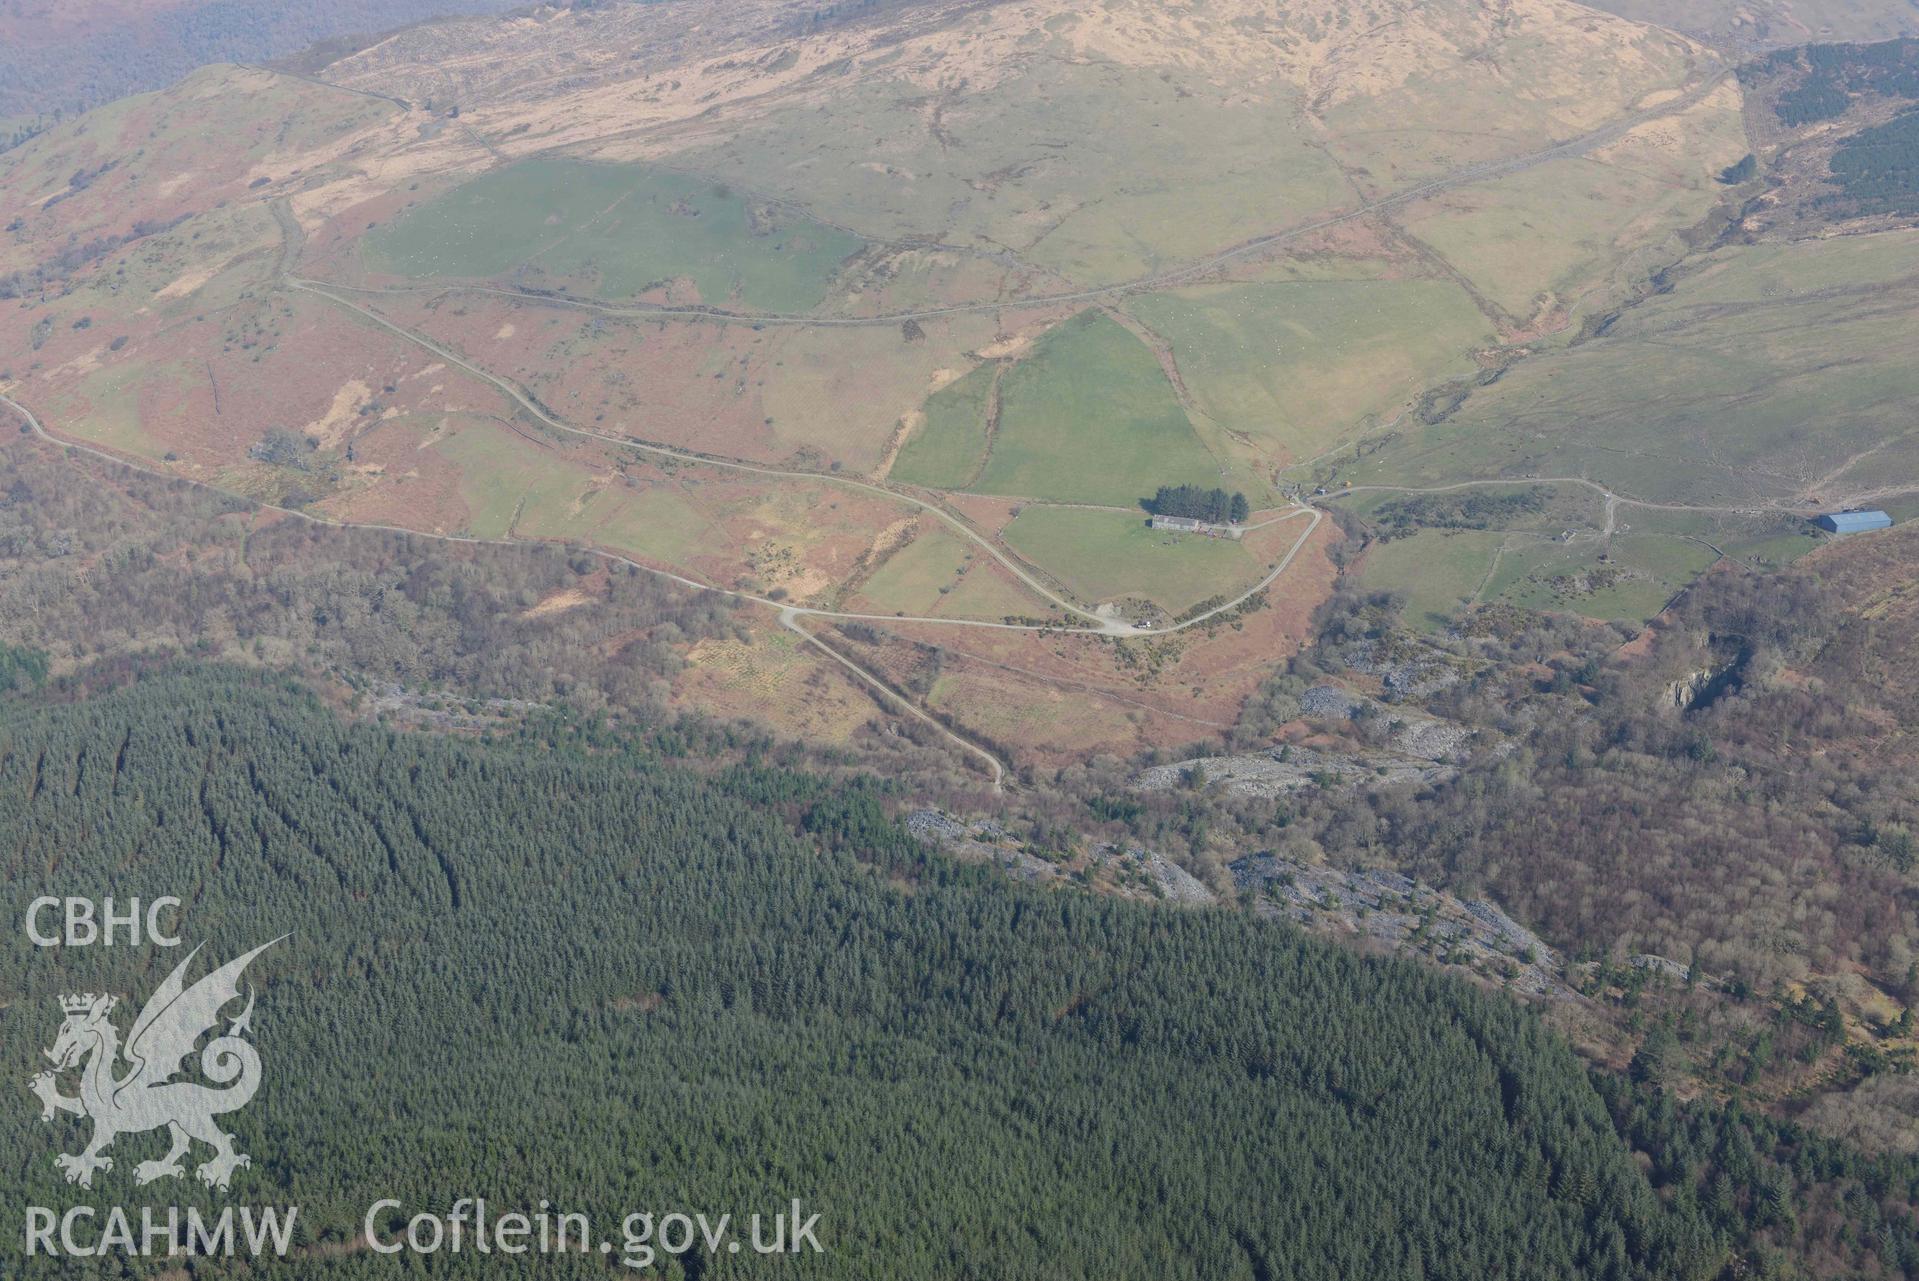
[365,157,862,311]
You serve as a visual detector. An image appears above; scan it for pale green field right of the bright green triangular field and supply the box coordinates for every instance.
[1130,280,1493,460]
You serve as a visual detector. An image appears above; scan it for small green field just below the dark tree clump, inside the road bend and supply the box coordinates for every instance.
[1006,504,1261,614]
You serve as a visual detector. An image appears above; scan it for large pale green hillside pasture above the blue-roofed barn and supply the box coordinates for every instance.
[1341,232,1919,504]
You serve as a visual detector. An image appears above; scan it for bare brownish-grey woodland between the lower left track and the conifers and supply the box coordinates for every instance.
[0,441,735,711]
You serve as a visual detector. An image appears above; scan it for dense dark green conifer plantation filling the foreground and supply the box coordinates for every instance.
[0,665,1919,1279]
